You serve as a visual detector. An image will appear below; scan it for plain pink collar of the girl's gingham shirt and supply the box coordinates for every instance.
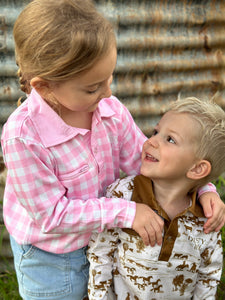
[28,89,114,147]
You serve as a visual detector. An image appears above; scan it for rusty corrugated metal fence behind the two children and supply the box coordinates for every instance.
[0,0,225,271]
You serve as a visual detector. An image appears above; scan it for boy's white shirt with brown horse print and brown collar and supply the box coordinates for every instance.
[88,175,223,300]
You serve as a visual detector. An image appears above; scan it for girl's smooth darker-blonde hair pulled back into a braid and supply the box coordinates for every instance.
[13,0,116,93]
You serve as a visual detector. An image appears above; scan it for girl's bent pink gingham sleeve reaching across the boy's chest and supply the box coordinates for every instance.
[3,138,136,234]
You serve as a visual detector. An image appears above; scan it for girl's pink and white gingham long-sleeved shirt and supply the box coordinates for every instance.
[1,89,216,253]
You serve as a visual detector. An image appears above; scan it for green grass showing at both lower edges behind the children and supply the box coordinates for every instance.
[0,177,225,300]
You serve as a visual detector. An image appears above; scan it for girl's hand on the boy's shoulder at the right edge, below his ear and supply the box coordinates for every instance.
[199,192,225,233]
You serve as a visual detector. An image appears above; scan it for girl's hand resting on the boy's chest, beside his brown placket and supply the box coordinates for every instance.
[132,203,164,247]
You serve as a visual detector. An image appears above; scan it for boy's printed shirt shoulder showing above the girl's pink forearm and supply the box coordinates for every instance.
[106,175,135,200]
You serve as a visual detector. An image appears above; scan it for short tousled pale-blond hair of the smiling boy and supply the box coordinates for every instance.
[169,97,225,187]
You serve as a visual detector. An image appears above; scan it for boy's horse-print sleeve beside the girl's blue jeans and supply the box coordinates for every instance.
[87,229,119,300]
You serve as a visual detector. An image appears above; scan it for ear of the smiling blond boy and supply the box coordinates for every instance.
[186,160,211,180]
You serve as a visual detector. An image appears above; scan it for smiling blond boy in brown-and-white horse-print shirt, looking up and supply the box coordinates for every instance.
[88,98,225,300]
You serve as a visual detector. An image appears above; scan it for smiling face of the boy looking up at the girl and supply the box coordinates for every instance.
[141,111,199,183]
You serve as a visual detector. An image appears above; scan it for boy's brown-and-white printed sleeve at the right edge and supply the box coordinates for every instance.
[193,232,223,300]
